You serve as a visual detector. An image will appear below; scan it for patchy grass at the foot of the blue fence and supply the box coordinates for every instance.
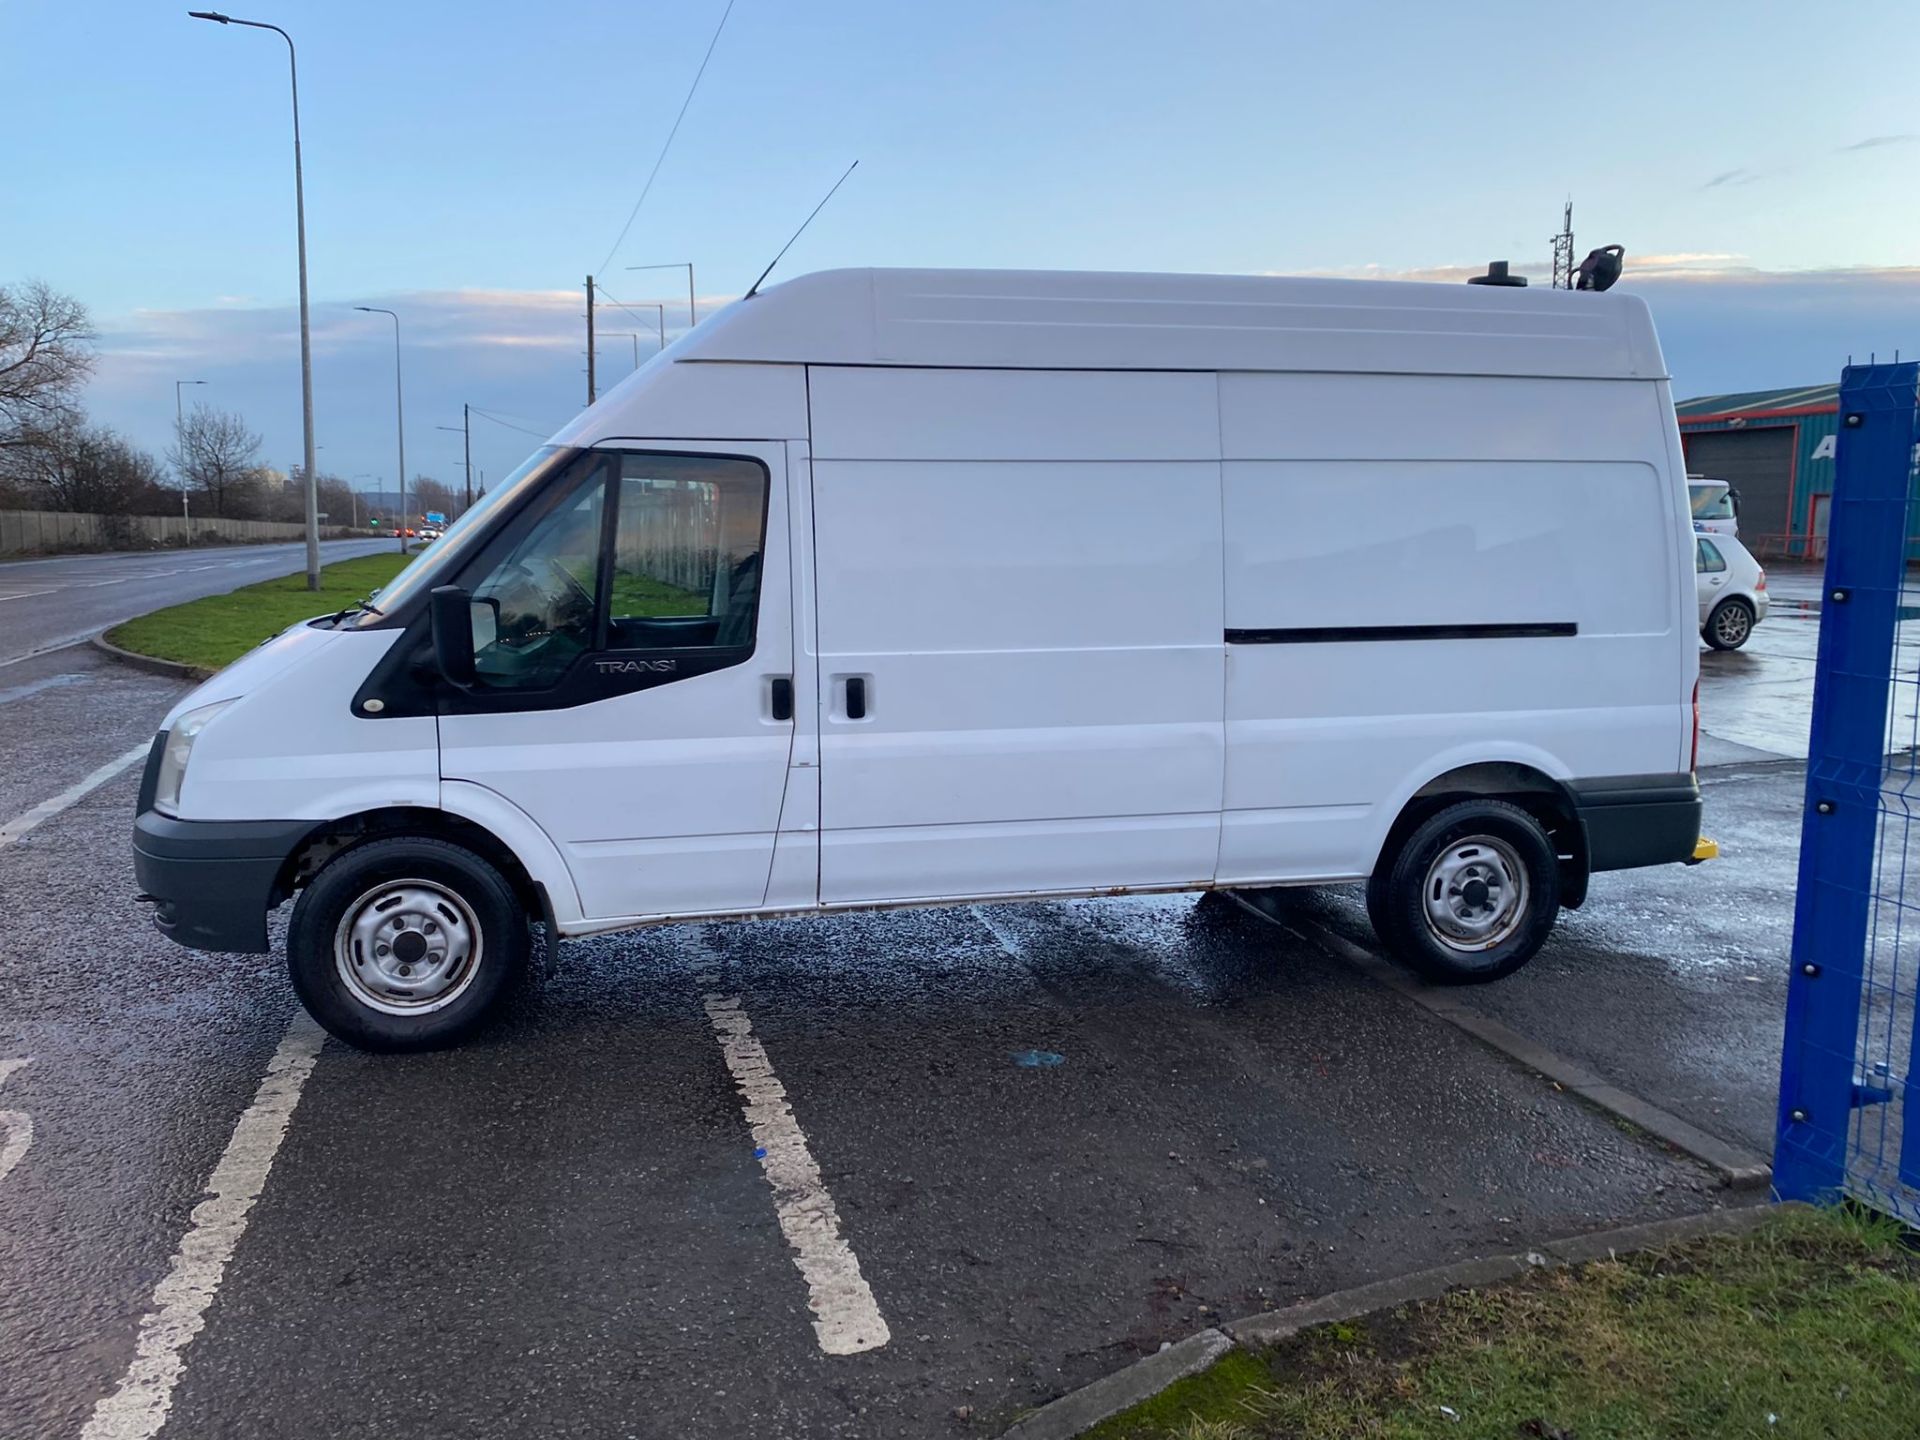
[1089,1210,1920,1440]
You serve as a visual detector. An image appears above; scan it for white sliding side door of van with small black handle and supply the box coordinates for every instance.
[810,369,1225,904]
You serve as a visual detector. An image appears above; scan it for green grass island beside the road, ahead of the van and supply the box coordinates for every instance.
[108,553,411,670]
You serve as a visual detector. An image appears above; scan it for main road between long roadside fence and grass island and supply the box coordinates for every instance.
[0,540,394,666]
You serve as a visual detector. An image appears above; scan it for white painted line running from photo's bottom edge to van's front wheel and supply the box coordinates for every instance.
[81,1012,326,1440]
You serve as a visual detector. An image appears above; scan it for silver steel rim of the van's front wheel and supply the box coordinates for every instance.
[334,879,482,1016]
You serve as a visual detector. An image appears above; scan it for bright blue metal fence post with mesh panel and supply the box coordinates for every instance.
[1774,361,1920,1225]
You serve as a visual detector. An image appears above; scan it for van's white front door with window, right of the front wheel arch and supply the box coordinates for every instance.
[440,440,795,920]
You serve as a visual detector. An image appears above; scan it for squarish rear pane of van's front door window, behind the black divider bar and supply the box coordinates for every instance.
[607,455,766,651]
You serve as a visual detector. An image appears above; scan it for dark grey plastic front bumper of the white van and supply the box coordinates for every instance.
[132,810,313,954]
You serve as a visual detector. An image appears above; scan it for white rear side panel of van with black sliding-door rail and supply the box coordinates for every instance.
[1219,374,1693,881]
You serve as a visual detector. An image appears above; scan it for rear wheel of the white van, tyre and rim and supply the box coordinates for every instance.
[1367,801,1559,985]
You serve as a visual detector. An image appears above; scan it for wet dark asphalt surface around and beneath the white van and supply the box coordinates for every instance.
[0,587,1811,1440]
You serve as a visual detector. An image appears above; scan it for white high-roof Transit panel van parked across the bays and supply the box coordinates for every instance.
[134,271,1699,1050]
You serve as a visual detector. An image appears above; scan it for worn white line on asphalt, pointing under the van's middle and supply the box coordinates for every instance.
[705,995,893,1356]
